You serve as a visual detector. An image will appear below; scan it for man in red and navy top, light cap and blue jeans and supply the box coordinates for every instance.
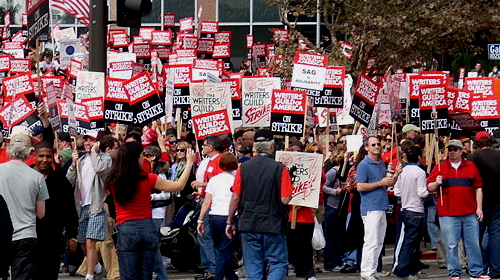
[427,139,490,280]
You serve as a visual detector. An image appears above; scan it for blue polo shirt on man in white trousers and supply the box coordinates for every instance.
[356,156,389,216]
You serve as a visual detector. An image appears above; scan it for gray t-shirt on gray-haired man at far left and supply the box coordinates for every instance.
[0,161,49,241]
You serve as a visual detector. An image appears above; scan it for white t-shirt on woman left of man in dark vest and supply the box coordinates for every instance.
[206,172,234,216]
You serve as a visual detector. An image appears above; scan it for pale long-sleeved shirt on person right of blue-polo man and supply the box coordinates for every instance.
[394,163,429,213]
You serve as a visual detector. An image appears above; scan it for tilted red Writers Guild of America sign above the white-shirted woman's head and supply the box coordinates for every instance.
[193,110,232,140]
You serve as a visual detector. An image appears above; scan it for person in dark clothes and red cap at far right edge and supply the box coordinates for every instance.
[469,131,500,278]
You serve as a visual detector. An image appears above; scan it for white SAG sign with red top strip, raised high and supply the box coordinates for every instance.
[292,52,328,90]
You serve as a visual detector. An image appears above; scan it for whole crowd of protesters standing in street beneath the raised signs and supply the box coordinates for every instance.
[0,107,500,280]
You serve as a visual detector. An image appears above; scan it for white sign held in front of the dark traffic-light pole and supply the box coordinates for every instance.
[75,71,104,102]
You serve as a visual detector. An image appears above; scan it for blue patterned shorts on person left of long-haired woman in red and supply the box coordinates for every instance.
[78,205,107,243]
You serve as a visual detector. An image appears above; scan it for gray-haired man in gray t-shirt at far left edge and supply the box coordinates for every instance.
[0,133,49,279]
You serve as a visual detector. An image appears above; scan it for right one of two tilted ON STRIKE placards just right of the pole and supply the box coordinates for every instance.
[123,72,165,125]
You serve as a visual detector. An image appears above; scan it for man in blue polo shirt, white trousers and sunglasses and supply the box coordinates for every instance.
[356,136,399,280]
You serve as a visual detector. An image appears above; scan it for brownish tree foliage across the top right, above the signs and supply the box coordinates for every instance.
[267,0,500,76]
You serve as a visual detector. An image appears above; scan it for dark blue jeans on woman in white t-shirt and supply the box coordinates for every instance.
[208,215,238,280]
